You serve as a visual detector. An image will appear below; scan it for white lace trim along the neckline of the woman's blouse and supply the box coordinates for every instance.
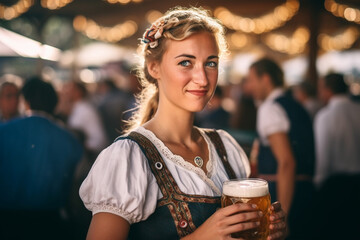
[135,126,221,195]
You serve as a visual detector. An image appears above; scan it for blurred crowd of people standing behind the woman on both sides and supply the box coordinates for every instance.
[0,59,360,239]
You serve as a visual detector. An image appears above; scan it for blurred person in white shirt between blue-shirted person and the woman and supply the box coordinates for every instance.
[67,81,107,159]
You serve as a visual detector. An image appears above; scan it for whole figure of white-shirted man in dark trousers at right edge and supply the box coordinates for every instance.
[310,73,360,240]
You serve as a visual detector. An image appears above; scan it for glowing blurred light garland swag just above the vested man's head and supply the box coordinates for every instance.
[264,27,310,54]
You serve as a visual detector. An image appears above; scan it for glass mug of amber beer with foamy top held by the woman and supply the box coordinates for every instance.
[221,178,271,240]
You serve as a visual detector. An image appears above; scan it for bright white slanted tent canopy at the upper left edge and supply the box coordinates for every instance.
[0,27,61,61]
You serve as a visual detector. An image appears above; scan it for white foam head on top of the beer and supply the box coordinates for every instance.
[223,179,269,198]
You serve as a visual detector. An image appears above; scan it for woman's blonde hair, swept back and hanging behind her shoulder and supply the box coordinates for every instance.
[125,7,227,132]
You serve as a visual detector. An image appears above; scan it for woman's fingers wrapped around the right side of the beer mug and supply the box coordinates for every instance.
[267,202,286,240]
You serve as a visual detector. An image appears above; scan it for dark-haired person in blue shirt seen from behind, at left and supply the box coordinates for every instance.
[0,77,82,240]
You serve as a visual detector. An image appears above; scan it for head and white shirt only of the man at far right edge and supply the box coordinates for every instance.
[314,73,360,186]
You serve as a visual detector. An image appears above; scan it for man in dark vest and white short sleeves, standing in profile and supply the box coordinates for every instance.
[248,58,315,239]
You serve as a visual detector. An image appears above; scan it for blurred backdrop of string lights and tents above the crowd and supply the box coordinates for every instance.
[0,0,360,85]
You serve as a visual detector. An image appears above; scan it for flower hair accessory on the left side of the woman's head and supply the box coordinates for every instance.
[142,17,179,48]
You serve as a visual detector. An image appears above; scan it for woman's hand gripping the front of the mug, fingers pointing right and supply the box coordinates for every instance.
[182,203,263,240]
